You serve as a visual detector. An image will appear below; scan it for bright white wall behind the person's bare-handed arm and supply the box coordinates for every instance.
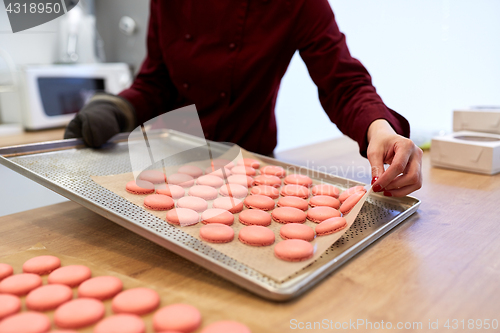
[276,0,500,151]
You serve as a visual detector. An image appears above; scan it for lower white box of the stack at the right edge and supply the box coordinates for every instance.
[431,131,500,175]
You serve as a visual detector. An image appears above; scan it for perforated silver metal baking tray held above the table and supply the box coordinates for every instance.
[0,130,420,301]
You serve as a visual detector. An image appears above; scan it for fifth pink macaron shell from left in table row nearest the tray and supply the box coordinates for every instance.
[153,303,201,333]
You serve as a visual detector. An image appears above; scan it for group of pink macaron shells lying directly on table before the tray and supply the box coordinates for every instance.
[0,255,250,333]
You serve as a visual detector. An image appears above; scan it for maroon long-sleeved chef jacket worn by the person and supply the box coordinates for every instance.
[120,0,410,155]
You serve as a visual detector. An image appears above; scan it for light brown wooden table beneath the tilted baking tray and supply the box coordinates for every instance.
[0,139,500,333]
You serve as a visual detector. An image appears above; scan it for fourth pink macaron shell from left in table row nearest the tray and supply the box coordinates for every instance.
[111,288,160,316]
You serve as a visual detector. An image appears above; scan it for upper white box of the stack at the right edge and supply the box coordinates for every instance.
[453,106,500,134]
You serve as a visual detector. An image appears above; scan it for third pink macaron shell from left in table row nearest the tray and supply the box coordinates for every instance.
[78,275,123,301]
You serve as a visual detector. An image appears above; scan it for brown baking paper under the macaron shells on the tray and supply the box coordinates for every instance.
[91,147,371,282]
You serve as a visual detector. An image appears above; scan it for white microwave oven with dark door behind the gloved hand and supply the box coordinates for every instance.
[0,63,132,130]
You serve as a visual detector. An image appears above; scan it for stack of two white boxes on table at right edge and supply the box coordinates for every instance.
[431,107,500,175]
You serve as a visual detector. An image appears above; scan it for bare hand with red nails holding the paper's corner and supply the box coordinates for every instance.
[367,119,423,197]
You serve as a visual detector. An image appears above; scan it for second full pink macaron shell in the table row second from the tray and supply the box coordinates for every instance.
[26,284,73,312]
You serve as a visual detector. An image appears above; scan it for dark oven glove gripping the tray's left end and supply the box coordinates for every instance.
[64,94,135,148]
